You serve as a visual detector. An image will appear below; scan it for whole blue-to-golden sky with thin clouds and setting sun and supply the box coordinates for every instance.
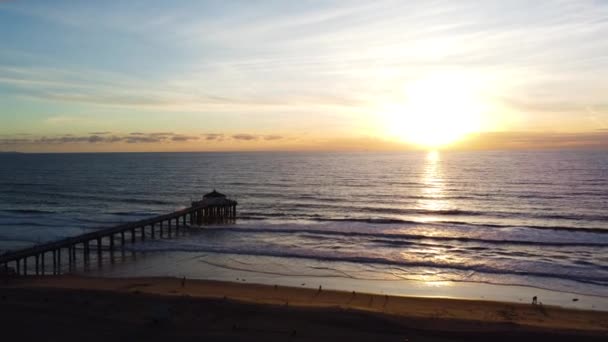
[0,0,608,152]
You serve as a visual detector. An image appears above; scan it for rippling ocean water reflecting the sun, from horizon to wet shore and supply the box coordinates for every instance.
[0,151,608,296]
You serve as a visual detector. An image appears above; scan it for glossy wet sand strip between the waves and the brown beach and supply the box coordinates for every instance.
[80,248,608,312]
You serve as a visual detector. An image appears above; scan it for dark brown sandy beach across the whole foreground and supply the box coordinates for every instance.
[0,276,608,341]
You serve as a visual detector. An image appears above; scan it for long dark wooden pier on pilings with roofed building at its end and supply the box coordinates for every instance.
[0,195,237,275]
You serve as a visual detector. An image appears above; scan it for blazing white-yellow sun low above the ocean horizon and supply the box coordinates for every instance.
[384,75,483,149]
